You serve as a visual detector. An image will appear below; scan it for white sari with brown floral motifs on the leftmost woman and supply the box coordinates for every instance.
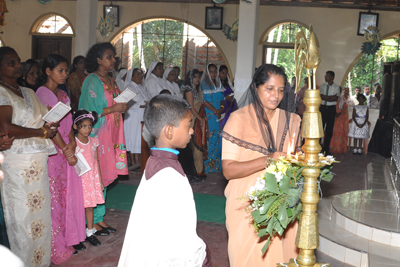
[0,86,57,267]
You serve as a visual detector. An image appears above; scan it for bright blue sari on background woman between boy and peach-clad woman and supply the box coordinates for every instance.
[200,82,225,173]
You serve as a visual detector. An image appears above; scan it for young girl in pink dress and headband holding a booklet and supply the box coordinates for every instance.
[73,109,104,246]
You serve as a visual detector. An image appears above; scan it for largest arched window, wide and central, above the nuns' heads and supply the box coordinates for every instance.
[112,19,229,77]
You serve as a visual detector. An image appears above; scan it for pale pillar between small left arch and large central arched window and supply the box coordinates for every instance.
[75,0,98,56]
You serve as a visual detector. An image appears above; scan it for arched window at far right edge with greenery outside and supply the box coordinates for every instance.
[345,34,400,92]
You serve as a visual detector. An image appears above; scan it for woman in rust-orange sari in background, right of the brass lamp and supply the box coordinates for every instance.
[329,87,354,153]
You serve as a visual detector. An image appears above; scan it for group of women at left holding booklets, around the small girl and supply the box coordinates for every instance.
[0,43,128,266]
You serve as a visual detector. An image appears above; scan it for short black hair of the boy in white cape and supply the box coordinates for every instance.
[144,94,190,139]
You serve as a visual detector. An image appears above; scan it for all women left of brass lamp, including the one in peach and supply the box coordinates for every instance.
[0,36,301,266]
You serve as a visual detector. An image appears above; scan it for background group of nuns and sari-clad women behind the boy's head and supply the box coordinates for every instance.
[117,61,237,181]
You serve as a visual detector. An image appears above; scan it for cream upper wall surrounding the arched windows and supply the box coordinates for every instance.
[0,0,400,84]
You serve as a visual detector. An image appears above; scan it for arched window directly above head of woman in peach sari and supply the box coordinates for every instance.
[261,22,309,78]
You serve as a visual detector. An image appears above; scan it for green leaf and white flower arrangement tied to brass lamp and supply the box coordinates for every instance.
[247,154,336,254]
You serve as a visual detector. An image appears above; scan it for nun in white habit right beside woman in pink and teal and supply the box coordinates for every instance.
[124,68,151,165]
